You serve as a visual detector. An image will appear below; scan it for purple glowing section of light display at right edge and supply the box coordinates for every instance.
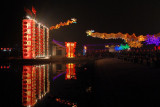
[145,35,160,46]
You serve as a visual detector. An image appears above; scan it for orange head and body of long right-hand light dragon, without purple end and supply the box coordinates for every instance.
[86,30,146,48]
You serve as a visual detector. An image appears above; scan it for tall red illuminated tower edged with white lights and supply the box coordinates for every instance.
[22,17,49,59]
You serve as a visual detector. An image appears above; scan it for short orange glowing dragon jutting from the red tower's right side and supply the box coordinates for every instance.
[50,18,77,30]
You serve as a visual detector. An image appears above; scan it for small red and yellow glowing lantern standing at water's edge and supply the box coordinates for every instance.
[65,42,76,58]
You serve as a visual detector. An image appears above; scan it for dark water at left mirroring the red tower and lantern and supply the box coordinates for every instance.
[0,63,92,107]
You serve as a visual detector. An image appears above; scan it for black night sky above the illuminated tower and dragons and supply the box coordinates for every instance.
[0,0,160,47]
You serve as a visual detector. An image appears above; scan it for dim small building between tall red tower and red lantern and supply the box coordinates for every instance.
[52,40,66,57]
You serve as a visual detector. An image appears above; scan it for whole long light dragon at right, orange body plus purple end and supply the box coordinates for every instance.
[86,30,160,48]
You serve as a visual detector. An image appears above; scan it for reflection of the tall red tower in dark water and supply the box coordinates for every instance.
[22,65,50,106]
